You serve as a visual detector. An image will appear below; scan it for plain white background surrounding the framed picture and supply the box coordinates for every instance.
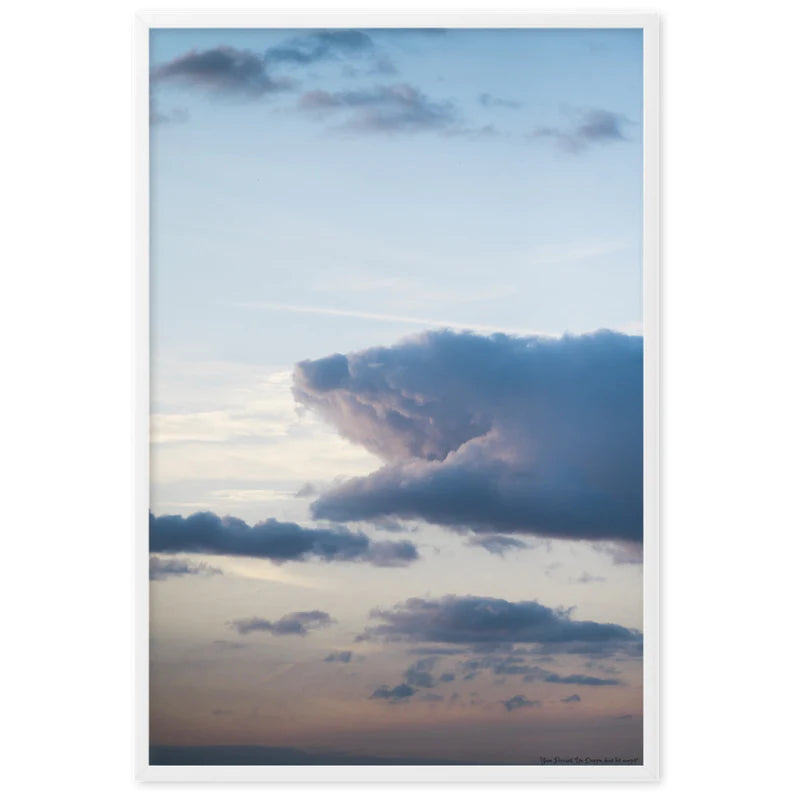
[0,0,800,798]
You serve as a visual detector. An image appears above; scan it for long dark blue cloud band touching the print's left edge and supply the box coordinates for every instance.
[150,511,419,567]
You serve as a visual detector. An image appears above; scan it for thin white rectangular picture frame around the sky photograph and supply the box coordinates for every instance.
[134,12,661,782]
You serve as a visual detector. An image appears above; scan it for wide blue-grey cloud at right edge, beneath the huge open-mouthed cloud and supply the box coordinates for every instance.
[359,595,642,649]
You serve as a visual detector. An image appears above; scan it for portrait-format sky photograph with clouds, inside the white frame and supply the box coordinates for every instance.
[149,23,643,765]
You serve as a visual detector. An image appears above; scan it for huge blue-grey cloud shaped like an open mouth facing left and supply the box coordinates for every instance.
[294,330,643,542]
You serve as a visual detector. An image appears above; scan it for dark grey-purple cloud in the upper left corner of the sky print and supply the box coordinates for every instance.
[150,46,293,98]
